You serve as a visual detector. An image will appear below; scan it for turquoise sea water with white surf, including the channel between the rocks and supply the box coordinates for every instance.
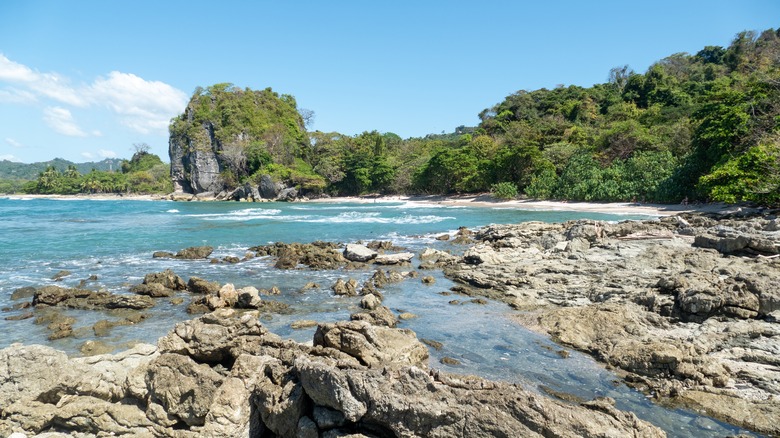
[0,198,756,436]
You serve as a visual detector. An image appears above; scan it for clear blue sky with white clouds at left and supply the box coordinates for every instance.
[0,0,780,162]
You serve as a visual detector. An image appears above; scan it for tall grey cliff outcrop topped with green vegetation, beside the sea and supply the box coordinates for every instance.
[168,84,308,194]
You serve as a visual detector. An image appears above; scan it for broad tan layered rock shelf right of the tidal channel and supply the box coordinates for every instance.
[445,212,780,436]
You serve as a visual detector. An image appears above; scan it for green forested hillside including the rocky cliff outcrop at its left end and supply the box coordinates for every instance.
[171,29,780,204]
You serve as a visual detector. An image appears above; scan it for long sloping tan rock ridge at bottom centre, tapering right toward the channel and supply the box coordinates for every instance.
[294,357,665,437]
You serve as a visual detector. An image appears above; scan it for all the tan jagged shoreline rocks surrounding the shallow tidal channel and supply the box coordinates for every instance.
[0,212,780,437]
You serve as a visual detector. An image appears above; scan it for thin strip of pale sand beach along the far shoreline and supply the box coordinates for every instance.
[4,194,739,216]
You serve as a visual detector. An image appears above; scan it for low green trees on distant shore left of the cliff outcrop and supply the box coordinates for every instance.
[21,144,173,195]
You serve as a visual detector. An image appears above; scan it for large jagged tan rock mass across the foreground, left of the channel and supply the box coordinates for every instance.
[0,309,665,437]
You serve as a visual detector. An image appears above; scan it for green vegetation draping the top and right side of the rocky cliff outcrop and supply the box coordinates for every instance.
[170,83,326,192]
